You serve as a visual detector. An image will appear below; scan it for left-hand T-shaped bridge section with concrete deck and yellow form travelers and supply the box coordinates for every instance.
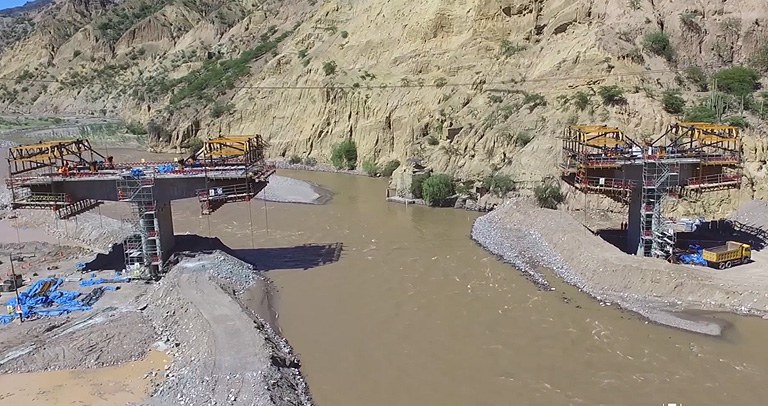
[6,135,275,277]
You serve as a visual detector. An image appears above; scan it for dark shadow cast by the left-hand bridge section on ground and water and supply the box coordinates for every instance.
[86,234,344,271]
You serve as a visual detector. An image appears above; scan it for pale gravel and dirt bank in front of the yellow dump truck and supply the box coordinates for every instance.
[472,199,768,335]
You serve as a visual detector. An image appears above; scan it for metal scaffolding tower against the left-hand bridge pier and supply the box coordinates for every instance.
[117,177,162,277]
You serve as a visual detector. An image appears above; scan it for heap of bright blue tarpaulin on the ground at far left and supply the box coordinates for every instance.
[0,278,91,324]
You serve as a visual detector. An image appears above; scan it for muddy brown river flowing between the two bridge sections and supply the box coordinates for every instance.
[4,146,768,406]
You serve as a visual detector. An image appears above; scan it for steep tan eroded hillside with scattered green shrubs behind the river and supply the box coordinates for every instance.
[0,0,768,203]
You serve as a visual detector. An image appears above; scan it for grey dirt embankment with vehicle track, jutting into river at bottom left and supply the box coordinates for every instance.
[146,251,312,405]
